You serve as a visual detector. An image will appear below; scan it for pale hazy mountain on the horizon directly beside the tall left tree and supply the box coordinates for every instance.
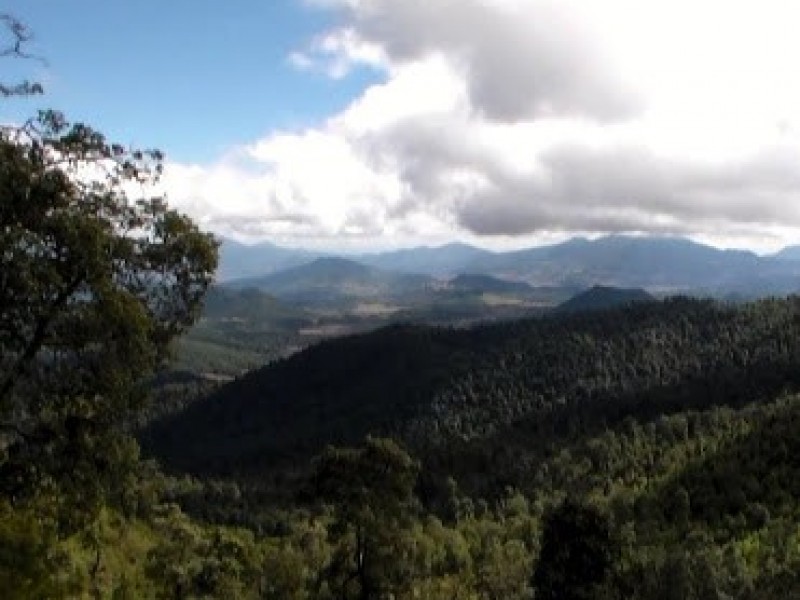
[217,239,319,282]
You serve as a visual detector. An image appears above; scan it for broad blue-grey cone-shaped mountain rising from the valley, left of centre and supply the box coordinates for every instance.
[228,258,434,304]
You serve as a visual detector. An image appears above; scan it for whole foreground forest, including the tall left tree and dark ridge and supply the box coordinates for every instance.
[0,10,800,600]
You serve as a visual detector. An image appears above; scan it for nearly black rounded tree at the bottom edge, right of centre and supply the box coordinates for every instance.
[533,500,619,600]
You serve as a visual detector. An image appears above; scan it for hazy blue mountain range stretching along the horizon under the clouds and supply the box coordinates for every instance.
[220,235,800,298]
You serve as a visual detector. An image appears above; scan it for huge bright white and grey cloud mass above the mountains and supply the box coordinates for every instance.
[166,0,800,252]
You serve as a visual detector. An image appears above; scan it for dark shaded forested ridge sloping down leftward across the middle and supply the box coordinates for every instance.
[144,297,800,492]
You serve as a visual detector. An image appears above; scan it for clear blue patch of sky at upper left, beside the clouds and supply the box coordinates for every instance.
[3,0,377,162]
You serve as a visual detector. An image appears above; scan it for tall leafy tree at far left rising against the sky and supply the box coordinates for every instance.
[0,15,217,530]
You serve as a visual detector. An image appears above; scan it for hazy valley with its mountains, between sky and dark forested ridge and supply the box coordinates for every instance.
[176,236,800,377]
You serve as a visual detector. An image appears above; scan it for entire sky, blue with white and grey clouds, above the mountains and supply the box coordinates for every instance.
[0,0,800,252]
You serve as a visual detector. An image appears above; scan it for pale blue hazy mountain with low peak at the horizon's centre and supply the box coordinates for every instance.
[357,243,493,277]
